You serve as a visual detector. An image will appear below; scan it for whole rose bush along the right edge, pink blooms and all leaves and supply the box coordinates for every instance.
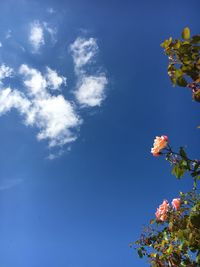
[131,28,200,267]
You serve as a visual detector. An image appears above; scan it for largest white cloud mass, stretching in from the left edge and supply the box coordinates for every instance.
[0,64,81,150]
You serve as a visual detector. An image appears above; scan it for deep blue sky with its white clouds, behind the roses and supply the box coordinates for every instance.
[0,0,200,267]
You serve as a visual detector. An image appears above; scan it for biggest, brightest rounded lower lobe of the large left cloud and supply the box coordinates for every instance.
[35,95,80,147]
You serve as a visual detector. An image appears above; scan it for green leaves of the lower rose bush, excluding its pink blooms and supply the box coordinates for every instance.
[134,146,200,267]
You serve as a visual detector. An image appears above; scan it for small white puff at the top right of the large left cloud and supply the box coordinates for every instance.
[46,67,67,90]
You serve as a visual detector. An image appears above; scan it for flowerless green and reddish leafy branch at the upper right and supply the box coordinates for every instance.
[161,27,200,102]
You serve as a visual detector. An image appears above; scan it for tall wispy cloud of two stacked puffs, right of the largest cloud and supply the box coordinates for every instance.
[70,37,108,107]
